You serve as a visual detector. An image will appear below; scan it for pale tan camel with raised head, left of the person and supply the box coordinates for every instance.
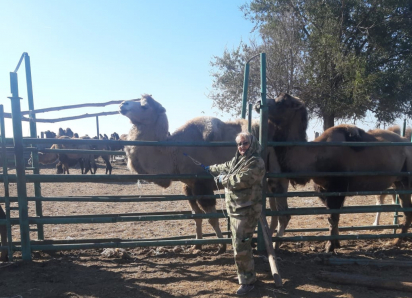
[120,94,287,253]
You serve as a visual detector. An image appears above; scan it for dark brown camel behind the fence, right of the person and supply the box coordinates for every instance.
[255,93,412,252]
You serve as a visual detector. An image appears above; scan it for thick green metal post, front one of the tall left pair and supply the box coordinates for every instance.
[9,72,31,261]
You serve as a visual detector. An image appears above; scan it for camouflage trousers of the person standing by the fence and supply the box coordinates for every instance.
[229,204,262,285]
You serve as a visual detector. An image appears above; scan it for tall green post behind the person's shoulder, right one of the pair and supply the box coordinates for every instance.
[257,53,268,251]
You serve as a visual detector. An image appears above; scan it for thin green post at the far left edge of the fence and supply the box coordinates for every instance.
[0,105,13,262]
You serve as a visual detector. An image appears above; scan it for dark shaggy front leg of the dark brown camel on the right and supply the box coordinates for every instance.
[320,196,345,252]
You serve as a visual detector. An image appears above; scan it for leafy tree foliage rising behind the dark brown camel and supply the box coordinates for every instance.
[210,0,412,129]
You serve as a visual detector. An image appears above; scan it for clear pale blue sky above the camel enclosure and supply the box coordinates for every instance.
[0,0,406,139]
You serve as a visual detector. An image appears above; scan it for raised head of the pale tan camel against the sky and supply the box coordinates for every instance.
[120,94,166,125]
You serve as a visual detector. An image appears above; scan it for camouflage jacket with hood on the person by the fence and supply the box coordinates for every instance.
[209,137,266,214]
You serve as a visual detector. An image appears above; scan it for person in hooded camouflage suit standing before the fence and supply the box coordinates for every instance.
[208,132,266,295]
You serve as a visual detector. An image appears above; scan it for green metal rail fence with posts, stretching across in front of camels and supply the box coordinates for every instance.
[0,54,412,260]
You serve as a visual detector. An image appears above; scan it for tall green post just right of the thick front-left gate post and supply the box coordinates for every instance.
[24,53,44,240]
